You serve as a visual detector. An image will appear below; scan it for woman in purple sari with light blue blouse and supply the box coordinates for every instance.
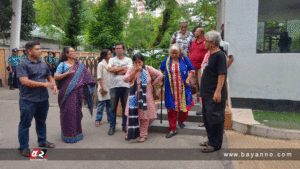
[54,46,96,143]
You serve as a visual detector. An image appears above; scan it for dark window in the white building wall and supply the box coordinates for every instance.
[256,0,300,53]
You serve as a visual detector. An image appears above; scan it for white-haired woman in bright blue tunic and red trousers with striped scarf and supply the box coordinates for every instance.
[160,44,195,138]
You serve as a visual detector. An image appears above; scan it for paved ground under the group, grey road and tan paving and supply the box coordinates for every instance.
[0,88,300,169]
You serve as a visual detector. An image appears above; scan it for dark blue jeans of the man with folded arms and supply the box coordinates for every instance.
[109,87,129,128]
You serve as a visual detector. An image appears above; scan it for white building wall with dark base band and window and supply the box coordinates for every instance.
[217,0,300,112]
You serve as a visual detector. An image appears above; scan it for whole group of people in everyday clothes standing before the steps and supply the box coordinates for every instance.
[16,21,233,156]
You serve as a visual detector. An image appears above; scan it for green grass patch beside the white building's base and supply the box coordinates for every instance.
[253,111,300,130]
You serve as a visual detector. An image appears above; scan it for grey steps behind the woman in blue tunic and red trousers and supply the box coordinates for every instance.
[149,102,206,135]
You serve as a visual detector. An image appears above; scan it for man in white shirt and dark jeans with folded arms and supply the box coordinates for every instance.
[108,43,132,135]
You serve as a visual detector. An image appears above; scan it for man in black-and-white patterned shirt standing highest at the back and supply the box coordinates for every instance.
[171,21,195,57]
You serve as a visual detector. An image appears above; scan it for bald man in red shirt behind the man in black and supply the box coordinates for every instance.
[189,27,207,114]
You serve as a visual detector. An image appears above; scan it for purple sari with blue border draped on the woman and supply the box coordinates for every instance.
[58,61,96,143]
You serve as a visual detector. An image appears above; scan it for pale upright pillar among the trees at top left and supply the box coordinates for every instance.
[9,0,22,53]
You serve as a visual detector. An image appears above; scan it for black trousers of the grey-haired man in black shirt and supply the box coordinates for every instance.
[202,99,226,150]
